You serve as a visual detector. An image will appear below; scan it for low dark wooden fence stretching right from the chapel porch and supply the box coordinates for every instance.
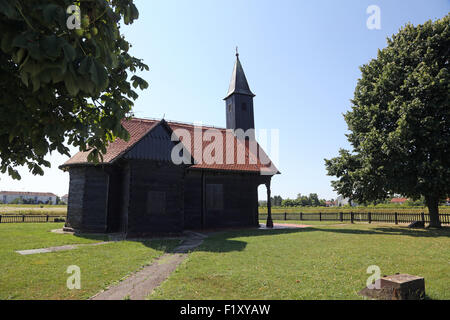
[259,212,450,224]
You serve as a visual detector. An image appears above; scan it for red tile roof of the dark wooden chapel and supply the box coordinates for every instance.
[61,118,278,175]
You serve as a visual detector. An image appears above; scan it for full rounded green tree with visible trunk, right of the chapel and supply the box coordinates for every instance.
[325,15,450,227]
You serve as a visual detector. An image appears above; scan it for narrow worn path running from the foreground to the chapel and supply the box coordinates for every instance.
[90,232,207,300]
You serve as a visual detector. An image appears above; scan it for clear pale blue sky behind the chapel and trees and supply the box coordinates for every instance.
[0,0,450,199]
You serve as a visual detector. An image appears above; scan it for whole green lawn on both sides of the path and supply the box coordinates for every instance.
[0,221,450,299]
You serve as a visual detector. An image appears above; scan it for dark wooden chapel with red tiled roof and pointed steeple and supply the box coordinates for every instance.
[60,55,279,236]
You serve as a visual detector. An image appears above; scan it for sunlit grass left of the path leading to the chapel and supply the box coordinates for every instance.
[0,223,179,300]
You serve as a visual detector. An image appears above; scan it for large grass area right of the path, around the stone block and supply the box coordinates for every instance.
[149,221,450,299]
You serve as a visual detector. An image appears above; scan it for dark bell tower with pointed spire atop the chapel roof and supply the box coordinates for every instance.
[224,50,255,132]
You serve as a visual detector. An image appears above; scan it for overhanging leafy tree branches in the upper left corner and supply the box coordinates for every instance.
[0,0,148,179]
